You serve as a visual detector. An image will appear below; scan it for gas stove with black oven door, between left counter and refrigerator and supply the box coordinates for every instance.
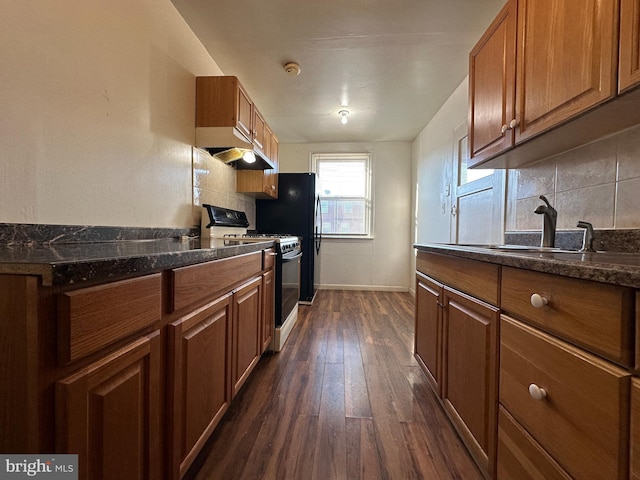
[201,204,302,352]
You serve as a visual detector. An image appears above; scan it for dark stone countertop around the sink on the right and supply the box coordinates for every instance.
[414,243,640,288]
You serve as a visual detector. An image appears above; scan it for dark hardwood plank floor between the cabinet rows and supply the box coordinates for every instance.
[187,290,482,480]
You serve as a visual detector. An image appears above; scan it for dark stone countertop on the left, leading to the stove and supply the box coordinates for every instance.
[0,238,273,286]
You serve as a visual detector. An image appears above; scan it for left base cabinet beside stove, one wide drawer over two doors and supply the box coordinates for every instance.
[167,249,266,479]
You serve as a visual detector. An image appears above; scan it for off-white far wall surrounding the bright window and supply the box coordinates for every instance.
[279,142,411,291]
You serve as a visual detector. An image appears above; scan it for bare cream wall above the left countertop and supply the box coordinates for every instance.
[0,0,222,228]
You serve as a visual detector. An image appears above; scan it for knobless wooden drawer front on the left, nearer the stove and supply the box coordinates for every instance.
[170,252,262,312]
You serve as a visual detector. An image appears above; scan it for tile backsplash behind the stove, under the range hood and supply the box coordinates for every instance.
[193,148,256,228]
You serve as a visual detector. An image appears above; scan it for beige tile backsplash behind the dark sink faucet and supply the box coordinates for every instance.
[506,126,640,231]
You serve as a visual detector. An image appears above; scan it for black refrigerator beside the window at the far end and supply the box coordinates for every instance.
[256,173,322,303]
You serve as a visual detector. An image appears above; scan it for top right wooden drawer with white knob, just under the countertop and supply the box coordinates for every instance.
[501,267,634,366]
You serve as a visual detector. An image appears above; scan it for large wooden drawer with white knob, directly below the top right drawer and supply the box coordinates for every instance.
[500,315,630,480]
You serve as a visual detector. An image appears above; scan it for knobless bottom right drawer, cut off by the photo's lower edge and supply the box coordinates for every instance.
[497,407,571,480]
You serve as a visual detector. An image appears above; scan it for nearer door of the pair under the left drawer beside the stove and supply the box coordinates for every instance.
[167,294,232,478]
